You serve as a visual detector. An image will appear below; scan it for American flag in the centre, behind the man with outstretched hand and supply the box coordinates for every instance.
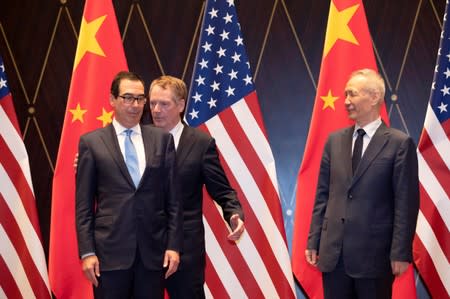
[186,0,295,298]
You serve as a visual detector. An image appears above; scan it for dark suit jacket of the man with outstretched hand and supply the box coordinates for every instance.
[177,125,244,271]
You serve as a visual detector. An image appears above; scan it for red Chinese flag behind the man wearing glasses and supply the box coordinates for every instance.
[49,0,128,299]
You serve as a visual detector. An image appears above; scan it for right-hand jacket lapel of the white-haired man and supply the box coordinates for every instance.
[352,123,389,185]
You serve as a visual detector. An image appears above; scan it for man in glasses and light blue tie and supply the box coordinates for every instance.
[76,72,182,299]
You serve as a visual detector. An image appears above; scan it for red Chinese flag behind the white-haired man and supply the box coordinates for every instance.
[292,0,416,298]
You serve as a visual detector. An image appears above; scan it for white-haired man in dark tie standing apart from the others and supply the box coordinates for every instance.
[305,69,419,299]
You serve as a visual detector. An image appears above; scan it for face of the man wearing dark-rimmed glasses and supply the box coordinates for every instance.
[110,79,145,128]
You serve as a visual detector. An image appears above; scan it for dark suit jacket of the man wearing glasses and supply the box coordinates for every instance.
[76,125,182,271]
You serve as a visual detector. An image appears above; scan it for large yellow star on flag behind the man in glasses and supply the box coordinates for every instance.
[74,15,106,69]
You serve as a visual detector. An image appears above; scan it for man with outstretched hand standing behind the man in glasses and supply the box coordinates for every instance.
[149,76,244,299]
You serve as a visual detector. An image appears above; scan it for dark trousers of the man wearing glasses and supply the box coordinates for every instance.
[94,251,165,299]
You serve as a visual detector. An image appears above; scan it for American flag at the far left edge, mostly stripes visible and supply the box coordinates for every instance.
[0,57,50,298]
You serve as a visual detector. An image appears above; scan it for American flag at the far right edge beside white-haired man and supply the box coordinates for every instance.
[414,1,450,298]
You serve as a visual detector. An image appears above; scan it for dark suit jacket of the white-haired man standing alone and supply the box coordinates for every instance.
[308,123,419,278]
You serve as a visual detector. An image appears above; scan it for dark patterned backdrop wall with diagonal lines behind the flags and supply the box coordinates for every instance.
[0,0,445,298]
